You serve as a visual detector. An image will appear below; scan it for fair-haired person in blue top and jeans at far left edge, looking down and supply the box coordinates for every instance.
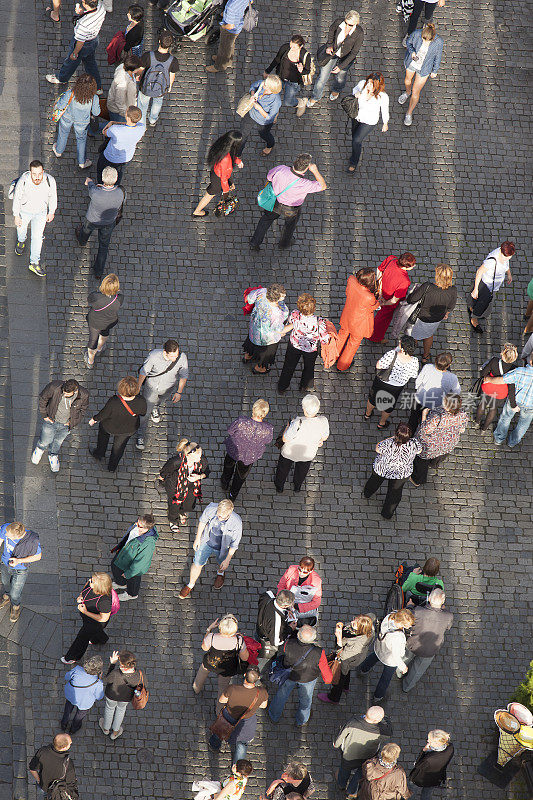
[0,522,42,622]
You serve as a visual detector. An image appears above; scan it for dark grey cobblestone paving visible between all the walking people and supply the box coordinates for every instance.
[2,0,532,800]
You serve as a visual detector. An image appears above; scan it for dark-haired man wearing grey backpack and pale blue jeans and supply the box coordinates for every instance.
[137,31,179,125]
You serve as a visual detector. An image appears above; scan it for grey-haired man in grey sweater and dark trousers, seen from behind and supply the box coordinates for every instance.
[76,167,125,278]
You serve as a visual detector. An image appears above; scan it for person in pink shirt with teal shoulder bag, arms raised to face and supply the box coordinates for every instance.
[250,153,328,248]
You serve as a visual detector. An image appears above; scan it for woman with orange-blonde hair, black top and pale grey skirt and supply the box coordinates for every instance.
[406,264,457,364]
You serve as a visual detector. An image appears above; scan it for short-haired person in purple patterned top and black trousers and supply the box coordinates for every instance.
[220,400,274,502]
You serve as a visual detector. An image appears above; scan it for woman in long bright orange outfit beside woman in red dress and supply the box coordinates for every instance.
[337,268,379,372]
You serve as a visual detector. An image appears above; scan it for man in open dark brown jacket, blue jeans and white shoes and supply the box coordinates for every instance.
[31,378,89,472]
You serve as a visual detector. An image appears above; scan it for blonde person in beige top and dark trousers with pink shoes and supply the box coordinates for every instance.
[318,613,376,703]
